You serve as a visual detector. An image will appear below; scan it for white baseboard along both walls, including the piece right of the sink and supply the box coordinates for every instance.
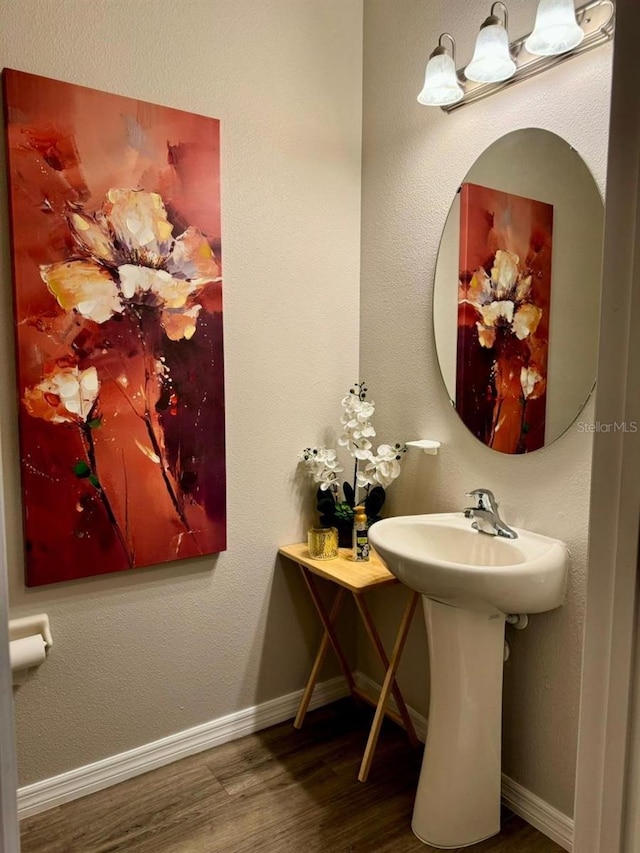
[18,672,574,853]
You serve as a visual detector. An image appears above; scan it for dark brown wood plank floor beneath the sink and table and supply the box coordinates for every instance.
[17,700,562,853]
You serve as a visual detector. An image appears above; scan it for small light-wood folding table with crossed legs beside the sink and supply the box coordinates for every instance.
[279,544,419,782]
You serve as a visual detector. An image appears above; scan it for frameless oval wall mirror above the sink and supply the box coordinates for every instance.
[433,127,604,456]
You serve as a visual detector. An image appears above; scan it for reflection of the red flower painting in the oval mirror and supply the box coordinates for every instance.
[456,183,553,453]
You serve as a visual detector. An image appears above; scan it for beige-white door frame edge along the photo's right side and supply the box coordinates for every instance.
[574,0,640,853]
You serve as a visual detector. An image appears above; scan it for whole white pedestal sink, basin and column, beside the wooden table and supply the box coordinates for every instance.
[369,513,568,849]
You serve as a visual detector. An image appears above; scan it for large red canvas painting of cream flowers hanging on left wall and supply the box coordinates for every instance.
[4,70,226,586]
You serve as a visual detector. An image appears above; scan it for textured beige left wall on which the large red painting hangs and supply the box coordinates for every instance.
[0,0,362,784]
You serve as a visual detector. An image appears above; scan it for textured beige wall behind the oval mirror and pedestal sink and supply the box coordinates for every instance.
[359,0,611,815]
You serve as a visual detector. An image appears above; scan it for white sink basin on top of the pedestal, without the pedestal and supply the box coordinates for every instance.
[369,512,568,614]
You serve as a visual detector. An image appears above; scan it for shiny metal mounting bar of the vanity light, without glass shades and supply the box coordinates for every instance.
[441,0,615,113]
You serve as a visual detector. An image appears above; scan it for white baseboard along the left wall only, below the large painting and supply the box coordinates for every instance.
[18,676,349,819]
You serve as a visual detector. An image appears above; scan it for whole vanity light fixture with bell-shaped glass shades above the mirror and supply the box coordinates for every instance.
[418,0,615,112]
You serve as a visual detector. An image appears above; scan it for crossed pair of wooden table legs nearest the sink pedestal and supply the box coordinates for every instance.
[355,592,419,782]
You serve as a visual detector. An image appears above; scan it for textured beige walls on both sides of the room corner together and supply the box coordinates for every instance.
[0,0,610,814]
